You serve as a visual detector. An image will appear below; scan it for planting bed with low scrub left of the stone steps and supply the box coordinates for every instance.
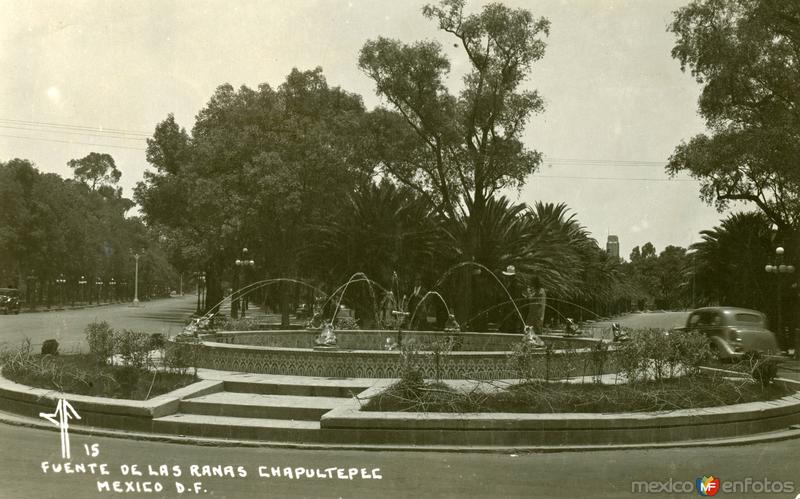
[3,354,196,400]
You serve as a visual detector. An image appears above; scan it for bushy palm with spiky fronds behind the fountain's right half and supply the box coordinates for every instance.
[446,197,624,324]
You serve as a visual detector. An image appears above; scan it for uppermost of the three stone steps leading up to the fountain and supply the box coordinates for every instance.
[225,376,374,398]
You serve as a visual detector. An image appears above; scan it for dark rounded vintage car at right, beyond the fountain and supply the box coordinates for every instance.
[681,307,780,359]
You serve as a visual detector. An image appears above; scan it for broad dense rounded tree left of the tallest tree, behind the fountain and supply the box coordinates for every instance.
[136,68,364,314]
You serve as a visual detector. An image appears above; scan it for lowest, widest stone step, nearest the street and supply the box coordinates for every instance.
[153,413,320,443]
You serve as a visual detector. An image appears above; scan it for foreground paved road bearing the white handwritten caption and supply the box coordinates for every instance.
[0,425,800,499]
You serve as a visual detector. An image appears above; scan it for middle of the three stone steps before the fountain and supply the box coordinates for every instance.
[179,392,347,422]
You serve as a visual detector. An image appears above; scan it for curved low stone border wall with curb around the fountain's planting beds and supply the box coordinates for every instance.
[0,380,800,453]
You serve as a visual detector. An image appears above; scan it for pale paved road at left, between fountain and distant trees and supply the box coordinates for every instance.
[0,295,197,352]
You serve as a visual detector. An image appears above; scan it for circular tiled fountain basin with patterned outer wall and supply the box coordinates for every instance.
[191,330,613,380]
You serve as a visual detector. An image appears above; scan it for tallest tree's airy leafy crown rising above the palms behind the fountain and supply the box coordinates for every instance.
[359,0,550,223]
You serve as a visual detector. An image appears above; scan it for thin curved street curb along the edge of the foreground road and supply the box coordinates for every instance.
[0,411,800,454]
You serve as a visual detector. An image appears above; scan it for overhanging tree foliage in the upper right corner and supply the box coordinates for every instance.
[667,0,800,252]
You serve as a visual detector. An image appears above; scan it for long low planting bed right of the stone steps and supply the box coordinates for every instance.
[362,374,794,413]
